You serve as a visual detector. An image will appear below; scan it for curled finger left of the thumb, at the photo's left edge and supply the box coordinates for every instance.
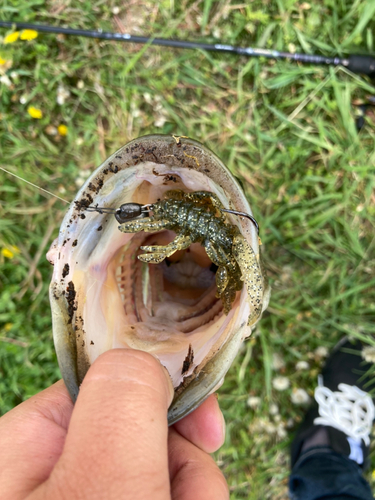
[0,380,73,500]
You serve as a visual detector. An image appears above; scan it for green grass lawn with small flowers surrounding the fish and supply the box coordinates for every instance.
[0,0,375,500]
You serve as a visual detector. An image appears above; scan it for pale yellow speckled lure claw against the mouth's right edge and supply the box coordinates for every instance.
[232,235,263,326]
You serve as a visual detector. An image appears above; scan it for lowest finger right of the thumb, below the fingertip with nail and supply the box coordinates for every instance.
[169,428,229,500]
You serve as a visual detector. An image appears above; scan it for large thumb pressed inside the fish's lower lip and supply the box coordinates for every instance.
[39,349,173,500]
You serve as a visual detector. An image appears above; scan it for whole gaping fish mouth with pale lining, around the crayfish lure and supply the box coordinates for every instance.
[47,135,270,424]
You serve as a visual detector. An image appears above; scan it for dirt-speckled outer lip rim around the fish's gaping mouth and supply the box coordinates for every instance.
[49,135,268,425]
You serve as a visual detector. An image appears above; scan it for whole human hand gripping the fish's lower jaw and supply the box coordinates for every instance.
[0,349,229,500]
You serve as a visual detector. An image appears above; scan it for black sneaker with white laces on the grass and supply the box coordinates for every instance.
[291,337,375,468]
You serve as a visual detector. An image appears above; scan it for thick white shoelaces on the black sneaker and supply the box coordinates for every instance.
[314,384,375,446]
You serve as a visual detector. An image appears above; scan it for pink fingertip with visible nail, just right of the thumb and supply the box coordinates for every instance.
[174,394,225,453]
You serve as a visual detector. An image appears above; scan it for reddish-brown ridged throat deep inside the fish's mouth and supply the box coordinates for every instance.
[117,231,222,334]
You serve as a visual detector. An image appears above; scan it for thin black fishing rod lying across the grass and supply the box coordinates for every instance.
[0,21,375,78]
